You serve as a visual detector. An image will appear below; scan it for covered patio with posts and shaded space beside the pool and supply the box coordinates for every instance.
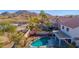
[54,31,72,47]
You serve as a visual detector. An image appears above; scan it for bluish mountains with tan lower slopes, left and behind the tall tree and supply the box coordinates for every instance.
[0,10,52,20]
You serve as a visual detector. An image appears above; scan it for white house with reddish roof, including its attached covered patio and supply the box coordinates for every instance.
[47,17,79,46]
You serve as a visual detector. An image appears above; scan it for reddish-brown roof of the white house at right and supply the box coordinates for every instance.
[61,17,79,28]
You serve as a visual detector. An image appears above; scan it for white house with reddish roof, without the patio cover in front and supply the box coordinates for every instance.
[60,18,79,46]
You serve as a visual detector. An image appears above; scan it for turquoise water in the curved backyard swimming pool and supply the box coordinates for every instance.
[32,37,50,47]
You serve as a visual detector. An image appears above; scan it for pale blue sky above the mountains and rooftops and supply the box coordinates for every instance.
[0,10,79,16]
